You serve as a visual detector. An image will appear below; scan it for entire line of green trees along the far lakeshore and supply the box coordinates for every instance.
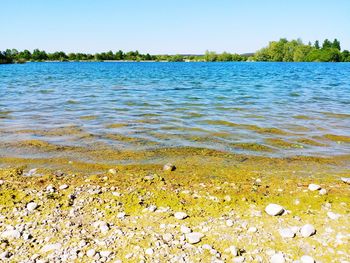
[0,38,350,64]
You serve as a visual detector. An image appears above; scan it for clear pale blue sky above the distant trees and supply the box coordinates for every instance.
[0,0,350,54]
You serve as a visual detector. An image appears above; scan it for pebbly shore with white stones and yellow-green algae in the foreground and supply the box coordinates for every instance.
[0,149,350,262]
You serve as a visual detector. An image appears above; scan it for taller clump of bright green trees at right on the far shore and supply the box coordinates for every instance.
[253,38,350,62]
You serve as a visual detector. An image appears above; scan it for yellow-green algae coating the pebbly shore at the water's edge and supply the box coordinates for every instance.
[0,148,350,262]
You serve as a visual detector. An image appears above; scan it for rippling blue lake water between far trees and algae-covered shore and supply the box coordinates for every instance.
[0,62,350,156]
